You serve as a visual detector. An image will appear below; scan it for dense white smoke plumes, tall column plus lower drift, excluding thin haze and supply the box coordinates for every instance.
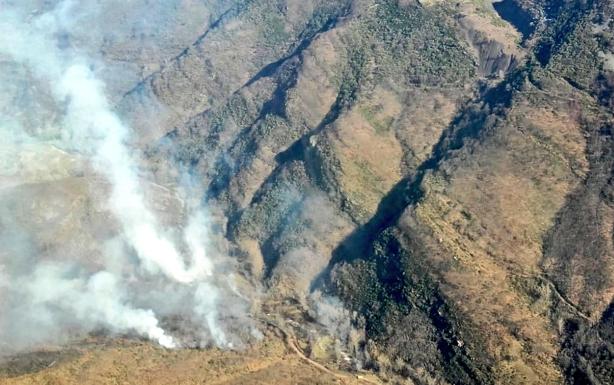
[0,1,250,348]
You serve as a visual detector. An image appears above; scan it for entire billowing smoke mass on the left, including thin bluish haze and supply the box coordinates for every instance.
[0,1,257,352]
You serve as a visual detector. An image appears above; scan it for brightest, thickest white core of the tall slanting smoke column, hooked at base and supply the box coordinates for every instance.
[59,63,212,283]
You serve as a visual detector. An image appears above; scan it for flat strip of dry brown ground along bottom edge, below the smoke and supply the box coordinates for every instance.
[0,327,381,385]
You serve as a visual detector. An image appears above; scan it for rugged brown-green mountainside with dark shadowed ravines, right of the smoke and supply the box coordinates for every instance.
[0,0,614,384]
